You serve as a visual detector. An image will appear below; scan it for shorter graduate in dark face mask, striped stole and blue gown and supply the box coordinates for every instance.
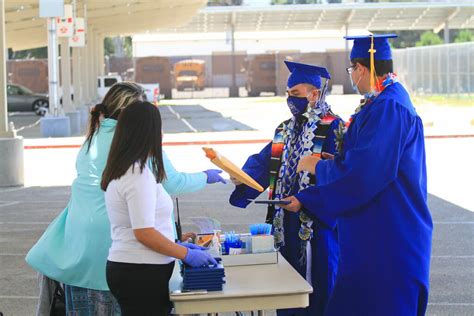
[230,61,341,316]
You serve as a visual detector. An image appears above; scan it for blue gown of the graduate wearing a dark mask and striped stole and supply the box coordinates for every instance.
[229,119,340,316]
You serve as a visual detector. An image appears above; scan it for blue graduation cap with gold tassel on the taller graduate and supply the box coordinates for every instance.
[344,34,398,60]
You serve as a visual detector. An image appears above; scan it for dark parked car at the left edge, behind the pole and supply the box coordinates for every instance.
[7,84,49,115]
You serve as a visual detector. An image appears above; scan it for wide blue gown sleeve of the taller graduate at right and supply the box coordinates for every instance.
[295,100,414,225]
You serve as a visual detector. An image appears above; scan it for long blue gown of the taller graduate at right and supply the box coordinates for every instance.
[296,83,433,316]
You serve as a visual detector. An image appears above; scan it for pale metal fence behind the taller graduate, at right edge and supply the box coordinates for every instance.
[393,42,474,94]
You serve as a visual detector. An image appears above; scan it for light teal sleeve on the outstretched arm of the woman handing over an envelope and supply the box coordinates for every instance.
[163,151,207,195]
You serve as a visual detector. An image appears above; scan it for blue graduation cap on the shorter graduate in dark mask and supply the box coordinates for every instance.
[285,60,331,89]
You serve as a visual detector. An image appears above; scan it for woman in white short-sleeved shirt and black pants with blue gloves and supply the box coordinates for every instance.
[101,102,216,316]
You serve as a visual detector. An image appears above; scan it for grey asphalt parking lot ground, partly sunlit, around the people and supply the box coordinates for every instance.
[0,98,474,316]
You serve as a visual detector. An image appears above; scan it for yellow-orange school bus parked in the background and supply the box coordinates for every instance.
[174,59,206,91]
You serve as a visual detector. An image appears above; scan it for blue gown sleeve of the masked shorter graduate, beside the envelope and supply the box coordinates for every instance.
[229,142,272,208]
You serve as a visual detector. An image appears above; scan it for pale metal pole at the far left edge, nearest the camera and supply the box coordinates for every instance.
[0,0,15,137]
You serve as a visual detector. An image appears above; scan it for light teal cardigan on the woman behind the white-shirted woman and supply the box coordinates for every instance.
[26,119,207,290]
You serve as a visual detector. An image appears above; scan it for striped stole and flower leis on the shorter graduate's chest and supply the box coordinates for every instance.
[266,110,337,265]
